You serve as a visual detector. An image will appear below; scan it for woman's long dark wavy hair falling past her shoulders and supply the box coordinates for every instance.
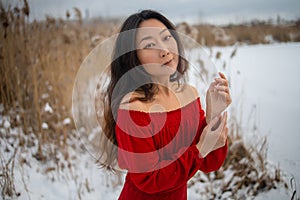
[99,10,188,169]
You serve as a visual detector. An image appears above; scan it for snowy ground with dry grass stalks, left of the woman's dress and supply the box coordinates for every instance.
[0,118,123,200]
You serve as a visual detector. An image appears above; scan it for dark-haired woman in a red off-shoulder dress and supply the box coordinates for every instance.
[102,10,231,200]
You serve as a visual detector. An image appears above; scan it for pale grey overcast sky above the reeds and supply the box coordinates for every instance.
[7,0,300,24]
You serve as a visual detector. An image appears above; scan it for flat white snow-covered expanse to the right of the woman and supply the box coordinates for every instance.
[213,43,300,195]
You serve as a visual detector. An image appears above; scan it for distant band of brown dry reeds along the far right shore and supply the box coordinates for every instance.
[194,19,300,46]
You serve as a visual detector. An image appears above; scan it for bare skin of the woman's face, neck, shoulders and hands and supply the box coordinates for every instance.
[120,19,231,157]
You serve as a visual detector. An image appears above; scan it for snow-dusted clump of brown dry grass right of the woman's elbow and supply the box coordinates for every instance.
[188,121,288,199]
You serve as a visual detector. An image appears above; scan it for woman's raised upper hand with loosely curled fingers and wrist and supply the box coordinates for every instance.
[206,72,232,122]
